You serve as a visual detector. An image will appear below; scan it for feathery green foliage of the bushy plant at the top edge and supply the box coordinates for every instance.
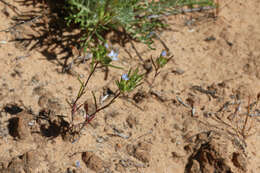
[66,0,213,48]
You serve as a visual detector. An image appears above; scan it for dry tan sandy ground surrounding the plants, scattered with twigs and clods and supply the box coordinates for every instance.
[0,0,260,173]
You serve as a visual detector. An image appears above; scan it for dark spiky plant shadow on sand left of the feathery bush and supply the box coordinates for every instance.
[8,0,85,72]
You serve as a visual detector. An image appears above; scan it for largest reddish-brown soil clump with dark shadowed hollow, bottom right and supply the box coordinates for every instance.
[185,133,247,173]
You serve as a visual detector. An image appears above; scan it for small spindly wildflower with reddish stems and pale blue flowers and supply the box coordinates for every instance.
[67,48,175,139]
